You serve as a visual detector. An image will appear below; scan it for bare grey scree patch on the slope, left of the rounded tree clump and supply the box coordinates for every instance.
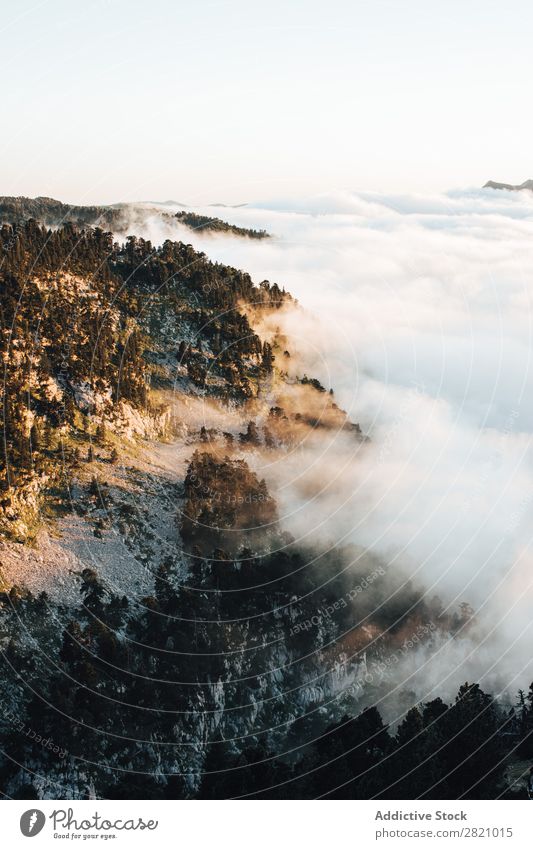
[0,440,195,606]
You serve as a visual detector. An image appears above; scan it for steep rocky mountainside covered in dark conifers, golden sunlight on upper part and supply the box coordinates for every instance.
[0,212,532,798]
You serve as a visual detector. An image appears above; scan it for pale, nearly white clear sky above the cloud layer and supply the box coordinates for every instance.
[0,0,533,204]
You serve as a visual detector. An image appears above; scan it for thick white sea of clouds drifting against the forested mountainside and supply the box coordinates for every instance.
[122,189,533,692]
